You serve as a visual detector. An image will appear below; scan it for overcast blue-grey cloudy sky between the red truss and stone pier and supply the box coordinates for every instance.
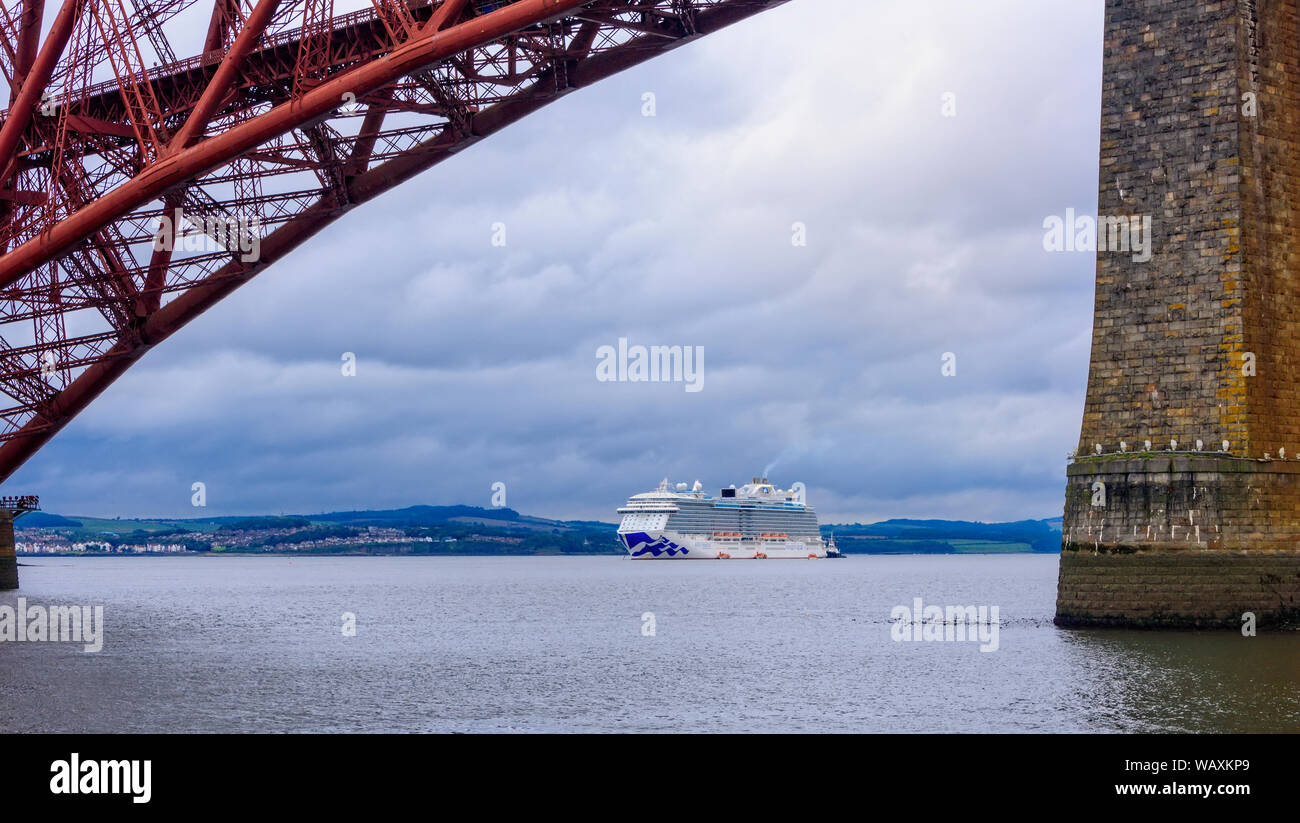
[7,0,1102,523]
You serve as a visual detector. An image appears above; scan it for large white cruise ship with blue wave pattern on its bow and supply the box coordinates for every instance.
[619,477,835,560]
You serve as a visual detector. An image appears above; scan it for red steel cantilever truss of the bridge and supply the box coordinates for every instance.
[0,0,785,481]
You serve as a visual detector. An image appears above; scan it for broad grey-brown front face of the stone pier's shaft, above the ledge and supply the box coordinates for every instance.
[1079,0,1247,454]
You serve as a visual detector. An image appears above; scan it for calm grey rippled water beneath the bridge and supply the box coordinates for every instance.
[0,555,1300,732]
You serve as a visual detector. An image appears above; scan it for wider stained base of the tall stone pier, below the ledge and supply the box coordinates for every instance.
[1057,454,1300,628]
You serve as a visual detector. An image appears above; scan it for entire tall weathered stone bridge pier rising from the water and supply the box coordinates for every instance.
[1057,0,1300,625]
